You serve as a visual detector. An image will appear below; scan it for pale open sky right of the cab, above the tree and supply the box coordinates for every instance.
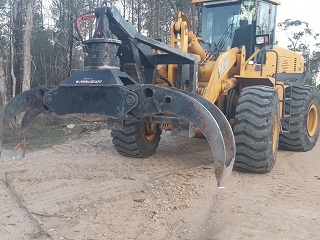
[276,0,320,47]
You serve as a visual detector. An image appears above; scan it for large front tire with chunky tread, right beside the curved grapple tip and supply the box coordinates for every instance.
[233,86,280,173]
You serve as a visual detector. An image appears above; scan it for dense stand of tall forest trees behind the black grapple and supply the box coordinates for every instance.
[0,0,204,107]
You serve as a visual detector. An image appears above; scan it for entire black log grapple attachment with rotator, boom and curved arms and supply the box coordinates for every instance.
[0,7,235,186]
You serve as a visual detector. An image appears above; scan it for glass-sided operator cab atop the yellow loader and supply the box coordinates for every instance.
[199,0,280,58]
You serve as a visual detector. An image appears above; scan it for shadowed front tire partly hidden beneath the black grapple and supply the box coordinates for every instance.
[111,121,161,158]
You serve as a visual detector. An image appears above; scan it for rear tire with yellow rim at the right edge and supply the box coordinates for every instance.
[279,86,320,152]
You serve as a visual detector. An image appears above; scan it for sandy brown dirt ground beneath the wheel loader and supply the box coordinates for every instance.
[0,126,320,240]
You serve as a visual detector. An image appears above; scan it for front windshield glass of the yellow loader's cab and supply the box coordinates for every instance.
[202,0,256,53]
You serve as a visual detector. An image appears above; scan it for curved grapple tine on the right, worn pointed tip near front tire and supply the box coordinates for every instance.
[132,85,235,187]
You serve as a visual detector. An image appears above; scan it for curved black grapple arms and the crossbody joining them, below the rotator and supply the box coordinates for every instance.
[0,84,235,187]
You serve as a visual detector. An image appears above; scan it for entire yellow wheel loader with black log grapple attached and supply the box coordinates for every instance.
[0,0,319,186]
